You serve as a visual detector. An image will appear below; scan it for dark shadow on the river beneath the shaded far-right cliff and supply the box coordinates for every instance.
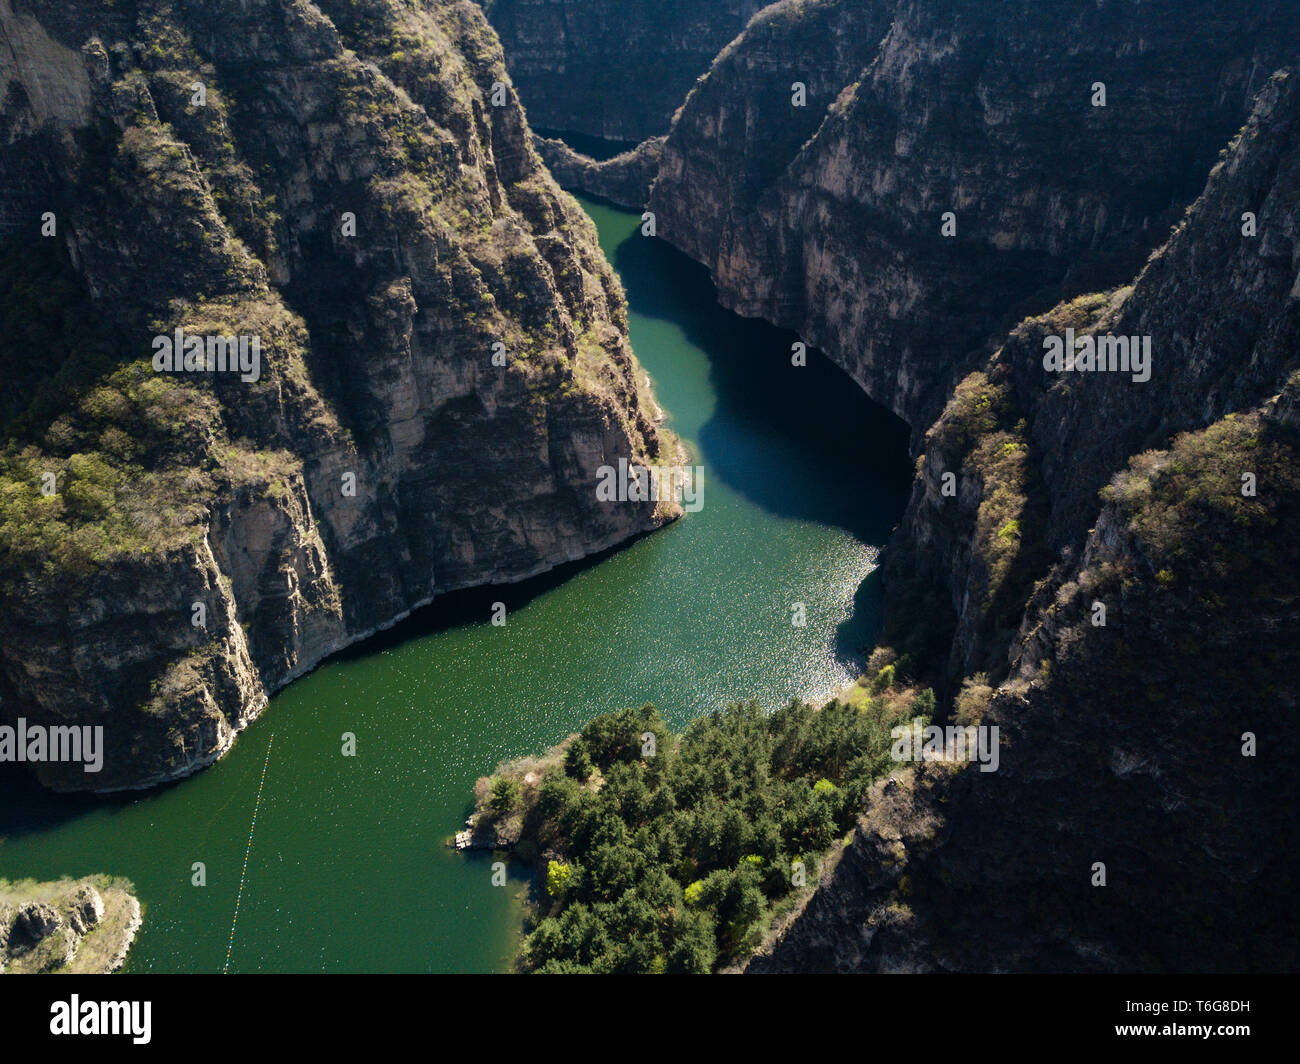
[614,221,911,545]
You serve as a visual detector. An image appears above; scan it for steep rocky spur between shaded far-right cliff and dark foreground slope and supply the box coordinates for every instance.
[883,73,1300,680]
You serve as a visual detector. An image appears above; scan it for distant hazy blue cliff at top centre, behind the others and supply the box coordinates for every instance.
[480,0,763,140]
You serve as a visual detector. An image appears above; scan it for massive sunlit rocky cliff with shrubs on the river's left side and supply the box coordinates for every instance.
[0,0,677,790]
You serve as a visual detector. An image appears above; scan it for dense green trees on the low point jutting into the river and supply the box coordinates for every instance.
[477,662,933,973]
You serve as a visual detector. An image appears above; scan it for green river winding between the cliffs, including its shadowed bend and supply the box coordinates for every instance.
[0,202,909,972]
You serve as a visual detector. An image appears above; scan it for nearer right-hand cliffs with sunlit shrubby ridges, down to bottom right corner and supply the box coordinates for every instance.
[750,70,1300,972]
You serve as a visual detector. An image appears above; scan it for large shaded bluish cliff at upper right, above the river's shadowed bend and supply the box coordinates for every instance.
[650,0,1300,438]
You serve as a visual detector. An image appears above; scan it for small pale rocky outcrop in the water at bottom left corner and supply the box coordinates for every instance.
[0,877,140,974]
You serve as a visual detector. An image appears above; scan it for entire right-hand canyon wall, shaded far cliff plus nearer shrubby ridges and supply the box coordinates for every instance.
[478,0,1300,972]
